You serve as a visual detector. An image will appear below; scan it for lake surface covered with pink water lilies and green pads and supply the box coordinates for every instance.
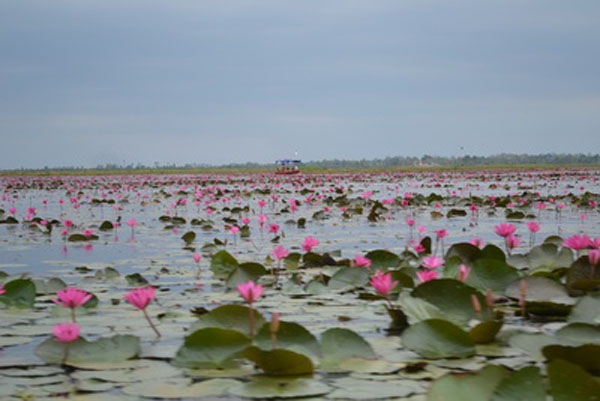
[0,169,600,401]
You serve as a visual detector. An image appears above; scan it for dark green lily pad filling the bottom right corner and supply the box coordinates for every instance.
[548,359,600,401]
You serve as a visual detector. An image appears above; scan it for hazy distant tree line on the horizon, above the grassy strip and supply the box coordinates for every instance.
[8,153,600,171]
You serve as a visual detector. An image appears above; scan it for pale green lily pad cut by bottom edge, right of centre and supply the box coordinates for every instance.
[427,365,509,401]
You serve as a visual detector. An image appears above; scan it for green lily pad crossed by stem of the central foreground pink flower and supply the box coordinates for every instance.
[190,305,265,336]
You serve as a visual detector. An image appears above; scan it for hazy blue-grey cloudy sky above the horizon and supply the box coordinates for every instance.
[0,0,600,170]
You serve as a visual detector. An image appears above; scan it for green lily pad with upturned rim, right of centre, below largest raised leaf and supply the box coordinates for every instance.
[411,279,485,324]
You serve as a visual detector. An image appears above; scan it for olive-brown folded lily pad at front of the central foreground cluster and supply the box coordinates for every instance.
[241,347,314,376]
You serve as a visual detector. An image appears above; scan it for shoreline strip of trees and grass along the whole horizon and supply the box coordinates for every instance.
[0,153,600,175]
